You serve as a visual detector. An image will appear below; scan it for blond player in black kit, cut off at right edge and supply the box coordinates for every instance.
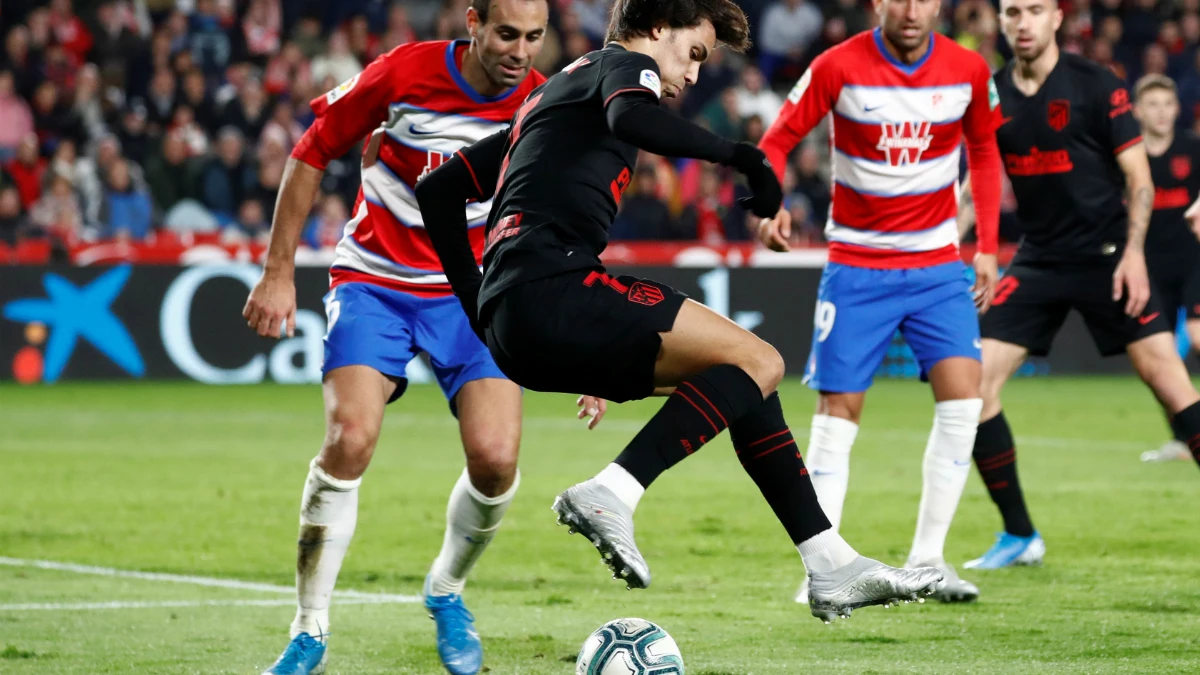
[1134,74,1200,461]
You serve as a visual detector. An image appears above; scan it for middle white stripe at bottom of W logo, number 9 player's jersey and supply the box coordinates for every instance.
[832,149,959,197]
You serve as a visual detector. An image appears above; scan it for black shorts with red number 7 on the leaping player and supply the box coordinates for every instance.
[482,269,688,402]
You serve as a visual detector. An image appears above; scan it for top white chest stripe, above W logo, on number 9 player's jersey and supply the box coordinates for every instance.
[834,83,971,124]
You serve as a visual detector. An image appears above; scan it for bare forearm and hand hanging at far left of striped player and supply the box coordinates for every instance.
[241,157,325,338]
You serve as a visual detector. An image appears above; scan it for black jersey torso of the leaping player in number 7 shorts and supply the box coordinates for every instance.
[463,44,661,306]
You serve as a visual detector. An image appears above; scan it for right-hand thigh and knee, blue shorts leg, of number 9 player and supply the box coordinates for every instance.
[900,262,983,401]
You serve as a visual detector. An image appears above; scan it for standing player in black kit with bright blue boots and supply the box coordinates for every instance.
[965,0,1200,569]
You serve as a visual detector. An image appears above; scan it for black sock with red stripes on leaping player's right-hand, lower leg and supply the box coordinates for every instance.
[730,393,832,544]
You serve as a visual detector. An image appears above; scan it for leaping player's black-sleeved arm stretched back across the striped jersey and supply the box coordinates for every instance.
[415,131,509,333]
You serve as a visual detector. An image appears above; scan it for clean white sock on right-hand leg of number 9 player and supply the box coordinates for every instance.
[908,399,983,563]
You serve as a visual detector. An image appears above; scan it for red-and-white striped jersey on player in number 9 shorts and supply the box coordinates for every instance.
[761,29,1000,268]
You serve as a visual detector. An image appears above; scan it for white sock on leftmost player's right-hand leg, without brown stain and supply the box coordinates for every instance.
[427,468,521,596]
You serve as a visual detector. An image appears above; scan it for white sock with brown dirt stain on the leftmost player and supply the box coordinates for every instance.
[292,459,362,641]
